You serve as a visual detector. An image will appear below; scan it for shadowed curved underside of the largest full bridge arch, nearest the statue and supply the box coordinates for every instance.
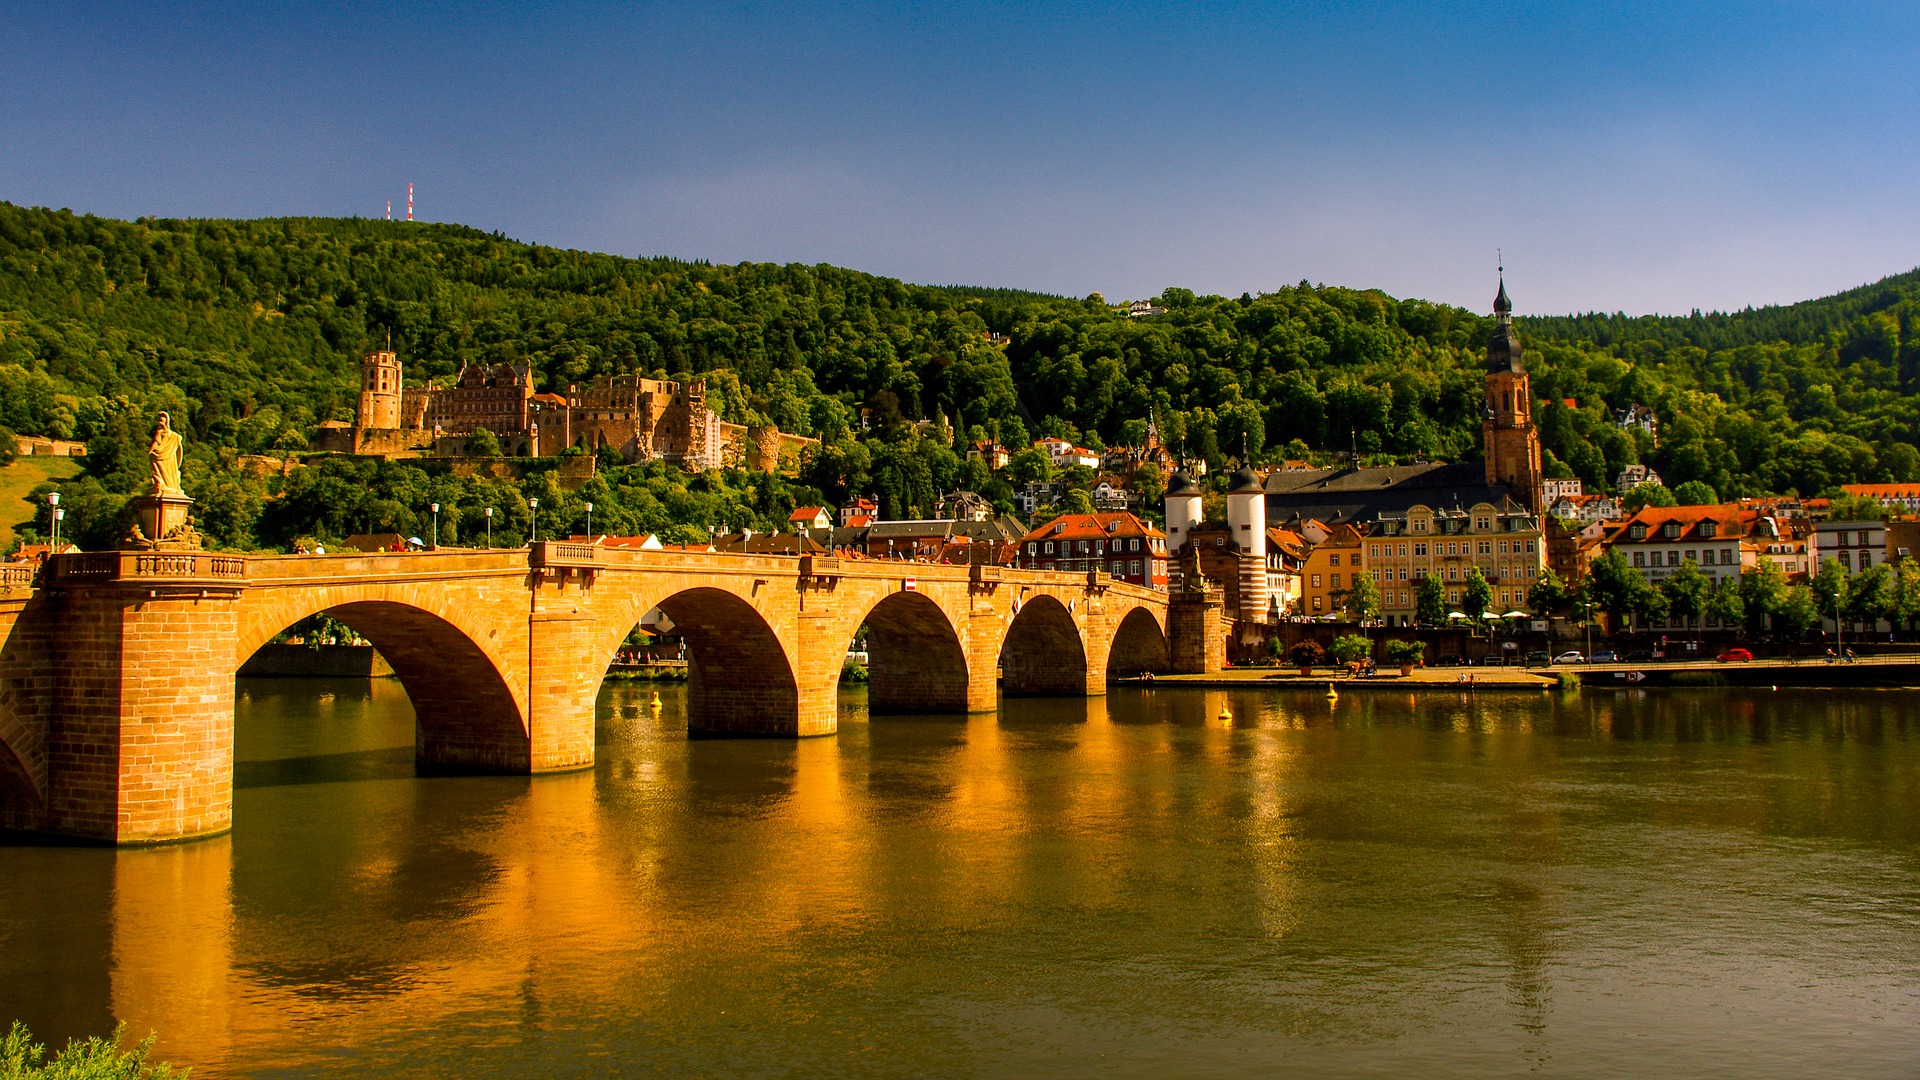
[234,596,532,773]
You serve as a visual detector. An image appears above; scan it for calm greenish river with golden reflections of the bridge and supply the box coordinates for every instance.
[0,678,1920,1078]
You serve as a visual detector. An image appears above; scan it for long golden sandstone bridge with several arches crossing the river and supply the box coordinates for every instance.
[0,542,1225,844]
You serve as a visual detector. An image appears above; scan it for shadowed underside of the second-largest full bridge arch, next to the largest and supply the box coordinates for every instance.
[597,584,794,736]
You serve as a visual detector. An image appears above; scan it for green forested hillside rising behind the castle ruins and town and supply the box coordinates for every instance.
[0,204,1920,496]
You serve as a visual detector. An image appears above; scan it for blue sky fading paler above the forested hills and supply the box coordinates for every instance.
[0,2,1920,313]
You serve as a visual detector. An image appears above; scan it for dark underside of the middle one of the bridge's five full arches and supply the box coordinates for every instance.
[847,592,970,713]
